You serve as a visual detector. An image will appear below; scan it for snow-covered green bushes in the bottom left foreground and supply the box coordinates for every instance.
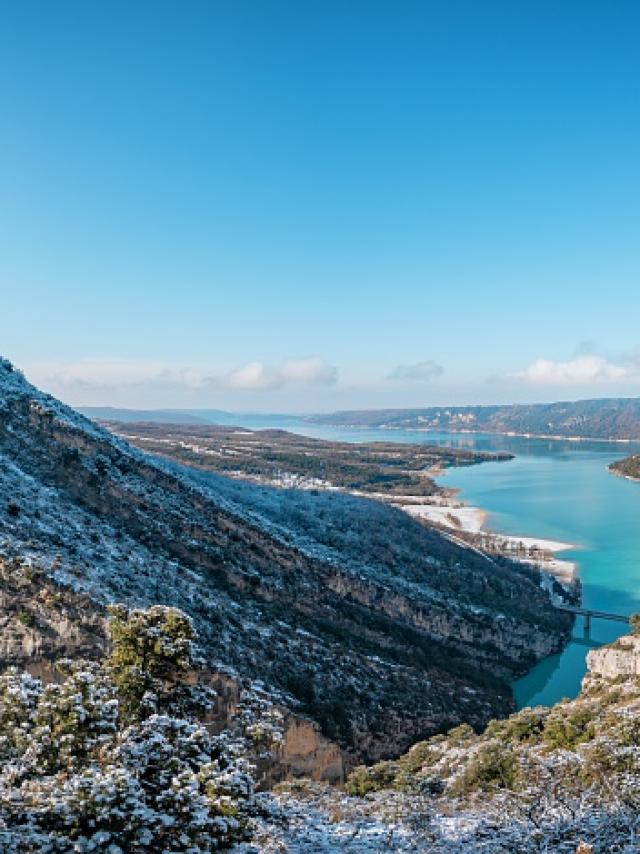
[0,607,253,854]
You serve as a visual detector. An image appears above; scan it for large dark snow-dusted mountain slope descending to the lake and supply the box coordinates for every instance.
[0,362,570,773]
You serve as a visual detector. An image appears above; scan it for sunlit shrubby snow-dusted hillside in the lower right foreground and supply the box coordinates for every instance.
[250,635,640,854]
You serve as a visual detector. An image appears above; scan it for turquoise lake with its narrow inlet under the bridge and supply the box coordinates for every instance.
[222,416,640,706]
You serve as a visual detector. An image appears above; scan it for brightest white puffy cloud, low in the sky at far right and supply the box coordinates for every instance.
[510,354,639,386]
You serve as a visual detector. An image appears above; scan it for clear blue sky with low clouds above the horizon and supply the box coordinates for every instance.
[0,0,640,411]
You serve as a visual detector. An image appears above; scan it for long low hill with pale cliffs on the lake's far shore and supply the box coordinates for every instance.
[308,397,640,440]
